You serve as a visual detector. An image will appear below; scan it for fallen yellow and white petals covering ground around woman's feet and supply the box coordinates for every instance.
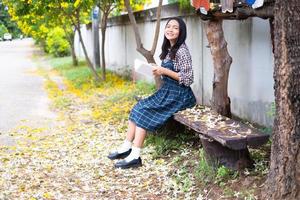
[0,55,268,200]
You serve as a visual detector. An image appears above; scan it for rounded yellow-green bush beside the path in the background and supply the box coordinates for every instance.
[46,27,70,57]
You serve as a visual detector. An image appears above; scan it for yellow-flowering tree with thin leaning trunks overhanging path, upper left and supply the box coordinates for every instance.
[4,0,100,81]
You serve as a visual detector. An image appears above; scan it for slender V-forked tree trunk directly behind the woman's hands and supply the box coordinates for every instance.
[125,0,162,89]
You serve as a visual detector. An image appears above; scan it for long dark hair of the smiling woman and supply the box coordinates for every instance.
[159,17,186,60]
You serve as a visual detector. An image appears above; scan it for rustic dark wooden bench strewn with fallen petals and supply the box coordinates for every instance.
[174,105,269,170]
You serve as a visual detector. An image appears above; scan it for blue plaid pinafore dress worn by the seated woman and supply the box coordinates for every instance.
[129,60,196,132]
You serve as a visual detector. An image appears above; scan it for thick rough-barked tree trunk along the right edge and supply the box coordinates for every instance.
[264,0,300,200]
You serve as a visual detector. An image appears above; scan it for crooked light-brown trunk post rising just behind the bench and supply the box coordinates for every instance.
[205,20,232,117]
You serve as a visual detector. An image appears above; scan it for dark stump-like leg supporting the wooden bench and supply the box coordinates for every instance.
[201,137,254,171]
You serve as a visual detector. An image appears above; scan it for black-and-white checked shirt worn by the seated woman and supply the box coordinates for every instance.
[165,43,194,86]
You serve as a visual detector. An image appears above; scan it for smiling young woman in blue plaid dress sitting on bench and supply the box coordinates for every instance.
[108,17,196,169]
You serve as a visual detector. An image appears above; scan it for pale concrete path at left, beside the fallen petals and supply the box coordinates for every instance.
[0,39,55,145]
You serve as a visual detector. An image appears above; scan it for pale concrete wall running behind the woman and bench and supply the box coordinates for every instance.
[74,9,274,126]
